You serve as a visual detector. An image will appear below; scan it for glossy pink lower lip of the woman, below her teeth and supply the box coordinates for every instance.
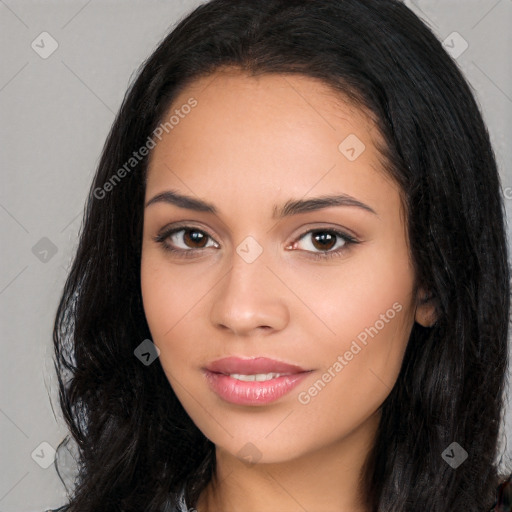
[205,370,311,405]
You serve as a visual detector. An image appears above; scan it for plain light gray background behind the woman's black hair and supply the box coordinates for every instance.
[0,0,512,512]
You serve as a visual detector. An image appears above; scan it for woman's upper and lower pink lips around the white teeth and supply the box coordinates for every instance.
[204,357,312,405]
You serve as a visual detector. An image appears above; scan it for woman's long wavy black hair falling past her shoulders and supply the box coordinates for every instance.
[54,0,510,512]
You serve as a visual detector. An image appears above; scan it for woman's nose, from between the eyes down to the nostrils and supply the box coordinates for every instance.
[211,243,289,336]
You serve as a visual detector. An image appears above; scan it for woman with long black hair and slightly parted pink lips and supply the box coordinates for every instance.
[50,0,510,512]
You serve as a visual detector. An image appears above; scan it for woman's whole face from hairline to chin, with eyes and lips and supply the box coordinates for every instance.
[141,71,428,462]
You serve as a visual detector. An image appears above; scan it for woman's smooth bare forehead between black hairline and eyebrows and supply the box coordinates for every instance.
[147,69,396,218]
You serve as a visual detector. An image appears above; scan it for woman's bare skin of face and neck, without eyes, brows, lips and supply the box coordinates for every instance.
[141,69,433,512]
